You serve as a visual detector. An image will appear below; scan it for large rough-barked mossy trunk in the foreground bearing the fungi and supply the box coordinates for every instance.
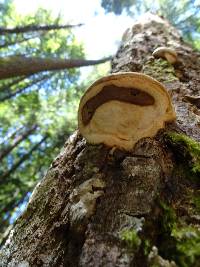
[0,15,200,267]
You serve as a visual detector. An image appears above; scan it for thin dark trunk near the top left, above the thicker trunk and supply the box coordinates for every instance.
[0,23,83,35]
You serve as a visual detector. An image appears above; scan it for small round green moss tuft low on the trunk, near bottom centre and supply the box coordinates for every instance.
[120,229,141,251]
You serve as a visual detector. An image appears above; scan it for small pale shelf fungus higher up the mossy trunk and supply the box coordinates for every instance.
[152,46,178,64]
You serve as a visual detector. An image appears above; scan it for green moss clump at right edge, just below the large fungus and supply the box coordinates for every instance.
[167,132,200,174]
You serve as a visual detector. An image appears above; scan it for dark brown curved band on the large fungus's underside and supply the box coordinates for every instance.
[82,84,155,125]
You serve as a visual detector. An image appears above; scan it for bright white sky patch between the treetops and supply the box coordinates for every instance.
[14,0,133,59]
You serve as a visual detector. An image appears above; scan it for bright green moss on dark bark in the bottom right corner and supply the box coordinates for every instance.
[158,203,200,267]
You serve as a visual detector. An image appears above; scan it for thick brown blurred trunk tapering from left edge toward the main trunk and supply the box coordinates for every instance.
[0,56,111,79]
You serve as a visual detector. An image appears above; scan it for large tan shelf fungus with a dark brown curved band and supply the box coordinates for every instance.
[78,72,176,150]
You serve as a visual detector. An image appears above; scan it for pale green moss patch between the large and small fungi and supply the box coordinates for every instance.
[143,58,178,83]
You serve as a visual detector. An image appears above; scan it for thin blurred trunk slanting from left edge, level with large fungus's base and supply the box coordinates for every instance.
[0,125,38,162]
